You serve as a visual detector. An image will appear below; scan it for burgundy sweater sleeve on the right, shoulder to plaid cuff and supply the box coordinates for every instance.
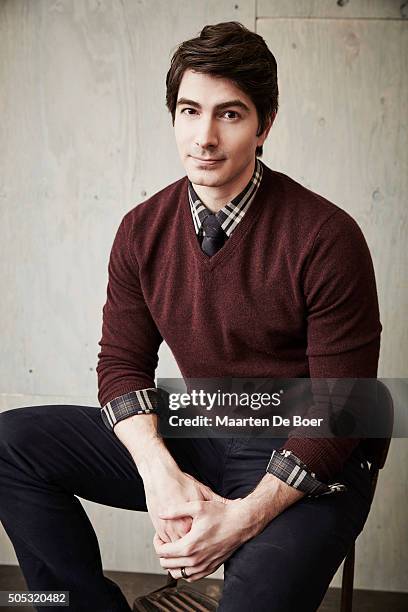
[282,210,382,481]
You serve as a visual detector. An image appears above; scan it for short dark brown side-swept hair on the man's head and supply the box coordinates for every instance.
[166,21,279,157]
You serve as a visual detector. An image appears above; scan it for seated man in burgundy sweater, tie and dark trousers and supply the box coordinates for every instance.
[0,22,381,612]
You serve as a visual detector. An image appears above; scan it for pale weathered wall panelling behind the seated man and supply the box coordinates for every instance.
[0,0,408,591]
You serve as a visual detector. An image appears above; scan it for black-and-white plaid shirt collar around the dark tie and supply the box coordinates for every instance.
[188,158,263,237]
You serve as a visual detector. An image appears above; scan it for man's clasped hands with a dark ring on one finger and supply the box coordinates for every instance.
[145,472,255,582]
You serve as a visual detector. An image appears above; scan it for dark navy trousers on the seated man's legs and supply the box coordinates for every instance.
[0,405,370,612]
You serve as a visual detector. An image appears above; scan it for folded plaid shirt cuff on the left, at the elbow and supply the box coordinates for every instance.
[101,387,160,431]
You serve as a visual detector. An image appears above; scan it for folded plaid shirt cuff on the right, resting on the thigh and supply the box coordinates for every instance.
[266,449,347,497]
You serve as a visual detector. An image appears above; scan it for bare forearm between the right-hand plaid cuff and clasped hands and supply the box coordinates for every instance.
[242,473,305,537]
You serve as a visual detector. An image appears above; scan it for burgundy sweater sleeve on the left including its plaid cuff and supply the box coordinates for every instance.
[96,213,162,428]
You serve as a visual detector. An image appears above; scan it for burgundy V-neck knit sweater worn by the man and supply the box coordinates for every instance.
[97,164,382,480]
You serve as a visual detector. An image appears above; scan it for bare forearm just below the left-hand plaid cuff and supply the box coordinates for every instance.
[114,414,180,481]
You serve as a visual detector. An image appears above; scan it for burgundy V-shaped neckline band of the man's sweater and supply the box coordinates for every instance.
[180,162,269,270]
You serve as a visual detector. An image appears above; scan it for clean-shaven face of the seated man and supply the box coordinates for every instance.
[174,70,269,187]
